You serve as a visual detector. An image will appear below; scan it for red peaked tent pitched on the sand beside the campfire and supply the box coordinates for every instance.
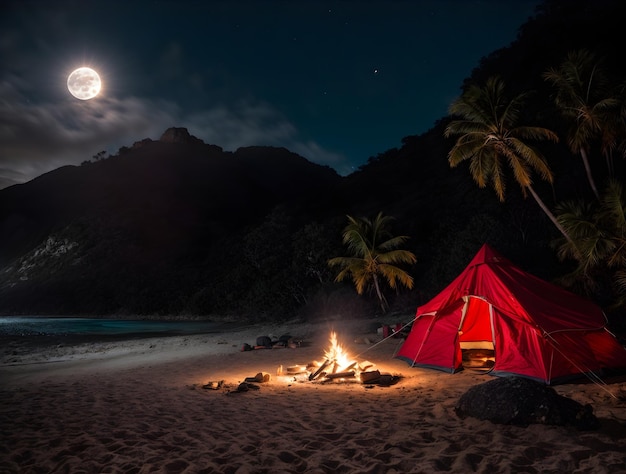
[396,244,626,384]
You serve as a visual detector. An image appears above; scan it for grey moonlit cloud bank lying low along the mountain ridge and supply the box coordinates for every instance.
[0,80,349,189]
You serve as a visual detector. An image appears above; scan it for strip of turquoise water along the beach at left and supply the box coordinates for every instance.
[0,317,222,336]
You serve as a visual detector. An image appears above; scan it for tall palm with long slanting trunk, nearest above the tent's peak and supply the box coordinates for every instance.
[444,76,569,244]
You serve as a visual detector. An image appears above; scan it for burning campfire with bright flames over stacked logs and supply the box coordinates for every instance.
[307,331,382,383]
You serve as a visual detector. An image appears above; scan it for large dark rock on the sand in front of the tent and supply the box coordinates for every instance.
[454,377,599,430]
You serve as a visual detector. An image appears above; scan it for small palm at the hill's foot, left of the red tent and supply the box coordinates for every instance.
[328,212,416,312]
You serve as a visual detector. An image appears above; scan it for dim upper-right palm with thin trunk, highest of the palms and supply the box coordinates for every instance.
[543,49,619,199]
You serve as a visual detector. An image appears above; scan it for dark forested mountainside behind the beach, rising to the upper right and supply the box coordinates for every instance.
[0,0,626,327]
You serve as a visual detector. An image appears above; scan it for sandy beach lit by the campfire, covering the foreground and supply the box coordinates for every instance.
[0,321,626,474]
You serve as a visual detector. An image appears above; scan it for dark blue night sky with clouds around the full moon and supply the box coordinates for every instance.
[0,0,540,188]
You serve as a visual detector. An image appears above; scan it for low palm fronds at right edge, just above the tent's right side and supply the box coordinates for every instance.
[556,180,626,310]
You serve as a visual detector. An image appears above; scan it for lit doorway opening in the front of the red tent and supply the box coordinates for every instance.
[458,296,496,372]
